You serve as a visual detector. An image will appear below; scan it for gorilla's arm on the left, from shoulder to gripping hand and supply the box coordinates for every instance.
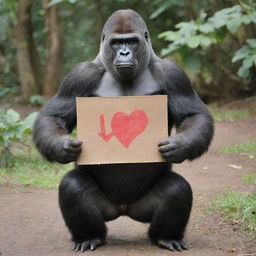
[33,62,102,163]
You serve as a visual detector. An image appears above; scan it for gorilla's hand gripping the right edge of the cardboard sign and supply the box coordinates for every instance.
[158,134,190,163]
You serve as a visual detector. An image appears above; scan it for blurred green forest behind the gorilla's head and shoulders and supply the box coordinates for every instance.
[0,0,256,104]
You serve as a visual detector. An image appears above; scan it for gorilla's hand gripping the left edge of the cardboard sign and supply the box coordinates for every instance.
[54,135,82,164]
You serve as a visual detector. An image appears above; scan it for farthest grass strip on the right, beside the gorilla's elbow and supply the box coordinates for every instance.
[211,107,252,122]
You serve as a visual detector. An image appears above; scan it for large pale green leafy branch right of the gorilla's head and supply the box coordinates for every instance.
[159,5,256,55]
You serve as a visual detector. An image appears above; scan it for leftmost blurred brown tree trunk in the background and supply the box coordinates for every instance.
[16,0,42,102]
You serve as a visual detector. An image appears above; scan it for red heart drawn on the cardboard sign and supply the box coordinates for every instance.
[111,110,148,148]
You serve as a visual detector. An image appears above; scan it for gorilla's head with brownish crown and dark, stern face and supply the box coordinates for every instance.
[100,10,151,80]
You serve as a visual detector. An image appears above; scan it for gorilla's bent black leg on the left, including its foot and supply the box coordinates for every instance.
[59,169,119,251]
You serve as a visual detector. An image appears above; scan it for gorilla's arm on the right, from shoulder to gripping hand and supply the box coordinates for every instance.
[159,60,214,163]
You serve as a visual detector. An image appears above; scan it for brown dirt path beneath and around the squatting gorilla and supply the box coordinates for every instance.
[0,118,256,256]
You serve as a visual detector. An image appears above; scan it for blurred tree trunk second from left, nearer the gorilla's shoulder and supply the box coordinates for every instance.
[42,0,62,97]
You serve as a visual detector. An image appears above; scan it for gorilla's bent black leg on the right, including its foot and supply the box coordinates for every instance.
[128,172,192,251]
